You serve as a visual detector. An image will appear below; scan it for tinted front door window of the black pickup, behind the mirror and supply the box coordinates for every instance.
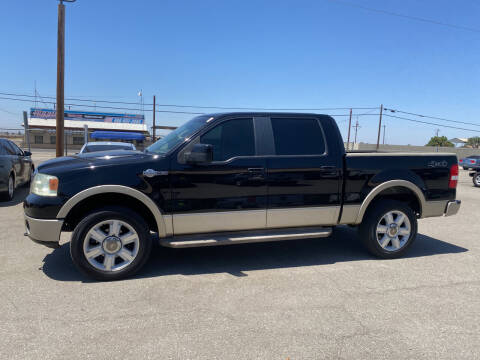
[200,119,255,161]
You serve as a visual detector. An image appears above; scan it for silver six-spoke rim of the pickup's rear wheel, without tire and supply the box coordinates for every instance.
[376,210,412,251]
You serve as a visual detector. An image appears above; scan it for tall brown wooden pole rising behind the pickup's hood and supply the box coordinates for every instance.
[55,0,75,157]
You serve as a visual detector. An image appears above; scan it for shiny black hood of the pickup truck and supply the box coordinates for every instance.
[38,150,160,175]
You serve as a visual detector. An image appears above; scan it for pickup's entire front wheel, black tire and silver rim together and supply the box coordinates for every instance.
[70,207,152,281]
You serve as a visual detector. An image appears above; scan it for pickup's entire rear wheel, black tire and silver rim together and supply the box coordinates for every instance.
[359,200,418,259]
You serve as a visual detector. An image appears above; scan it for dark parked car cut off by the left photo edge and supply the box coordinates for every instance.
[0,138,34,201]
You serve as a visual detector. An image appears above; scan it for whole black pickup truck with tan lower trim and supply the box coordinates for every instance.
[24,113,460,280]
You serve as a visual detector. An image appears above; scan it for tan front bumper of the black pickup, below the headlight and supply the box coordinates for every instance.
[24,215,63,248]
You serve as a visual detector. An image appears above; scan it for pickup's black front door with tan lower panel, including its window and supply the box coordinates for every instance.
[170,118,267,235]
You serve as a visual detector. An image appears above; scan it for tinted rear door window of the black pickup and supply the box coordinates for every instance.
[272,118,325,155]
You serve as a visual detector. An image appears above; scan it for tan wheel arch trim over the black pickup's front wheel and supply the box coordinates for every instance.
[57,185,170,237]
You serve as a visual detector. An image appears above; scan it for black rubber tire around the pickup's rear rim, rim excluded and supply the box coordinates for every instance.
[359,200,418,259]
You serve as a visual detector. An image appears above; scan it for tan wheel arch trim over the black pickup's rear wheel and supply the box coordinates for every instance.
[355,180,426,224]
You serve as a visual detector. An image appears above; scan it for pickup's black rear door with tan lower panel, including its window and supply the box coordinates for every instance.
[267,115,342,228]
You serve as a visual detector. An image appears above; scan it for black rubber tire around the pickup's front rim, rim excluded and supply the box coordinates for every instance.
[70,207,152,281]
